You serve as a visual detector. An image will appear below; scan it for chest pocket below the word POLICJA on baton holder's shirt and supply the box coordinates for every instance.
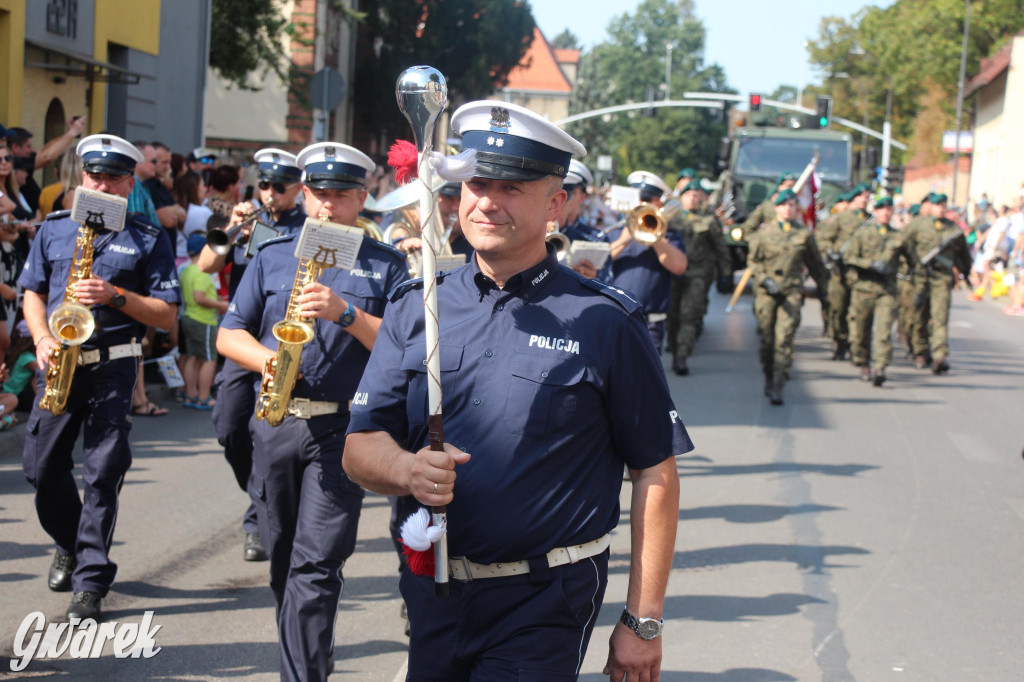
[504,351,586,436]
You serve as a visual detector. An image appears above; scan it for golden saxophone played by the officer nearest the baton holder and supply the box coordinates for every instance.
[256,214,333,426]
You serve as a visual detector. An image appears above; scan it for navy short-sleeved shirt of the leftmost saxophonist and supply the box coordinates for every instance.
[18,211,181,350]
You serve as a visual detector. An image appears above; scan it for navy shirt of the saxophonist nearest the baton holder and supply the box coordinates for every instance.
[221,233,409,402]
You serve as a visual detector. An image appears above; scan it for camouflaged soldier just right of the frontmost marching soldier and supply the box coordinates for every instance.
[814,182,871,360]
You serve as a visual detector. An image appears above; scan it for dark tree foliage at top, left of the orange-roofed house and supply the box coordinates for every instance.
[353,0,535,139]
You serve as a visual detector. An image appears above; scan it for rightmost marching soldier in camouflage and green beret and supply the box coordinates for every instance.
[903,191,971,374]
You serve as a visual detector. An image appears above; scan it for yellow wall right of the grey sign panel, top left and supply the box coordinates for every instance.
[90,0,160,133]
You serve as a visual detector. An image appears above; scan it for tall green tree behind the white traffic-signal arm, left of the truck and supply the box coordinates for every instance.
[566,0,731,182]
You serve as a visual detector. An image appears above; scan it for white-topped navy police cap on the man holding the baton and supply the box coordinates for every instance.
[452,99,587,182]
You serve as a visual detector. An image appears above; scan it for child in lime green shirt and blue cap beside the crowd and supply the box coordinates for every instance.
[180,232,227,410]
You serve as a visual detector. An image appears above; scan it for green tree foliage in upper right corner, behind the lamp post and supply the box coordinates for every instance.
[809,0,1024,161]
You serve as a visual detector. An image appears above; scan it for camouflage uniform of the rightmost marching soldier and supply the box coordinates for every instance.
[904,216,971,371]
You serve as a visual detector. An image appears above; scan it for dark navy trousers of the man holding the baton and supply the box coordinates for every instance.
[400,551,608,682]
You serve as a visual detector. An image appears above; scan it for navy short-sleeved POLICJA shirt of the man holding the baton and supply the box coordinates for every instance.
[348,248,693,563]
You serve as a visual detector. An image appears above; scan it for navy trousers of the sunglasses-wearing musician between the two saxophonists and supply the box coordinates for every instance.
[213,359,259,534]
